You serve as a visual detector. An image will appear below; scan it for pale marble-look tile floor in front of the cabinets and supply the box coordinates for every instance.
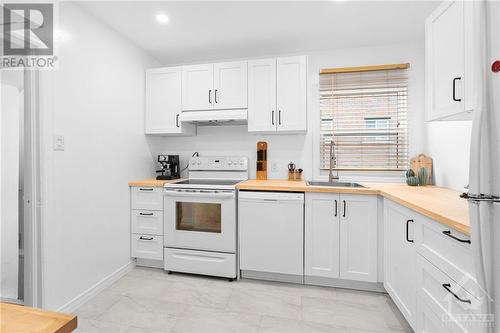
[76,267,411,333]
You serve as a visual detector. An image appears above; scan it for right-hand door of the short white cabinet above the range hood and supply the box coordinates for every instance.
[213,61,247,109]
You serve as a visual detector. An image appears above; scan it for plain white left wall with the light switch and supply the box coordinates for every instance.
[41,2,156,309]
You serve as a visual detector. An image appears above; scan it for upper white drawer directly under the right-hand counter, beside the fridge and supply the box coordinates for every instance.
[416,216,478,296]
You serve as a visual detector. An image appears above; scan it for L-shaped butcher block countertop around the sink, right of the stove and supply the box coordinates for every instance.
[237,180,470,235]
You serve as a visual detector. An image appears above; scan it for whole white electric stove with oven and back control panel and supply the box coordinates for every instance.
[164,156,248,279]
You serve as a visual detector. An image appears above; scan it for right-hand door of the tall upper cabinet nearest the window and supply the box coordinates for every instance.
[276,56,307,132]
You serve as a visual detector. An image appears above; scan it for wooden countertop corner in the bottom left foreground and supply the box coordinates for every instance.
[0,303,77,333]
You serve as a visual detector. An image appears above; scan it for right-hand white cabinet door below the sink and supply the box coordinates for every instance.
[339,194,377,282]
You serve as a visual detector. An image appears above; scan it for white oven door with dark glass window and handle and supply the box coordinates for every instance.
[163,189,236,253]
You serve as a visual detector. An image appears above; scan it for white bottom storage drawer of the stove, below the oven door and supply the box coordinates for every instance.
[164,248,236,278]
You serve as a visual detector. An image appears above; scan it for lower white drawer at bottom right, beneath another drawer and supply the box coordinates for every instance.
[417,255,481,333]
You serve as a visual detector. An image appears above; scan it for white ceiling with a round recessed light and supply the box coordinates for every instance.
[79,0,438,64]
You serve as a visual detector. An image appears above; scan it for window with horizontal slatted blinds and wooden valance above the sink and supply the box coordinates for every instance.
[320,64,409,171]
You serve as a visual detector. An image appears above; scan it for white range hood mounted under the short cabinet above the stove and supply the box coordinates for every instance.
[180,109,248,126]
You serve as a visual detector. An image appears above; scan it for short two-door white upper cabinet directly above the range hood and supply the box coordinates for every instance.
[182,61,247,111]
